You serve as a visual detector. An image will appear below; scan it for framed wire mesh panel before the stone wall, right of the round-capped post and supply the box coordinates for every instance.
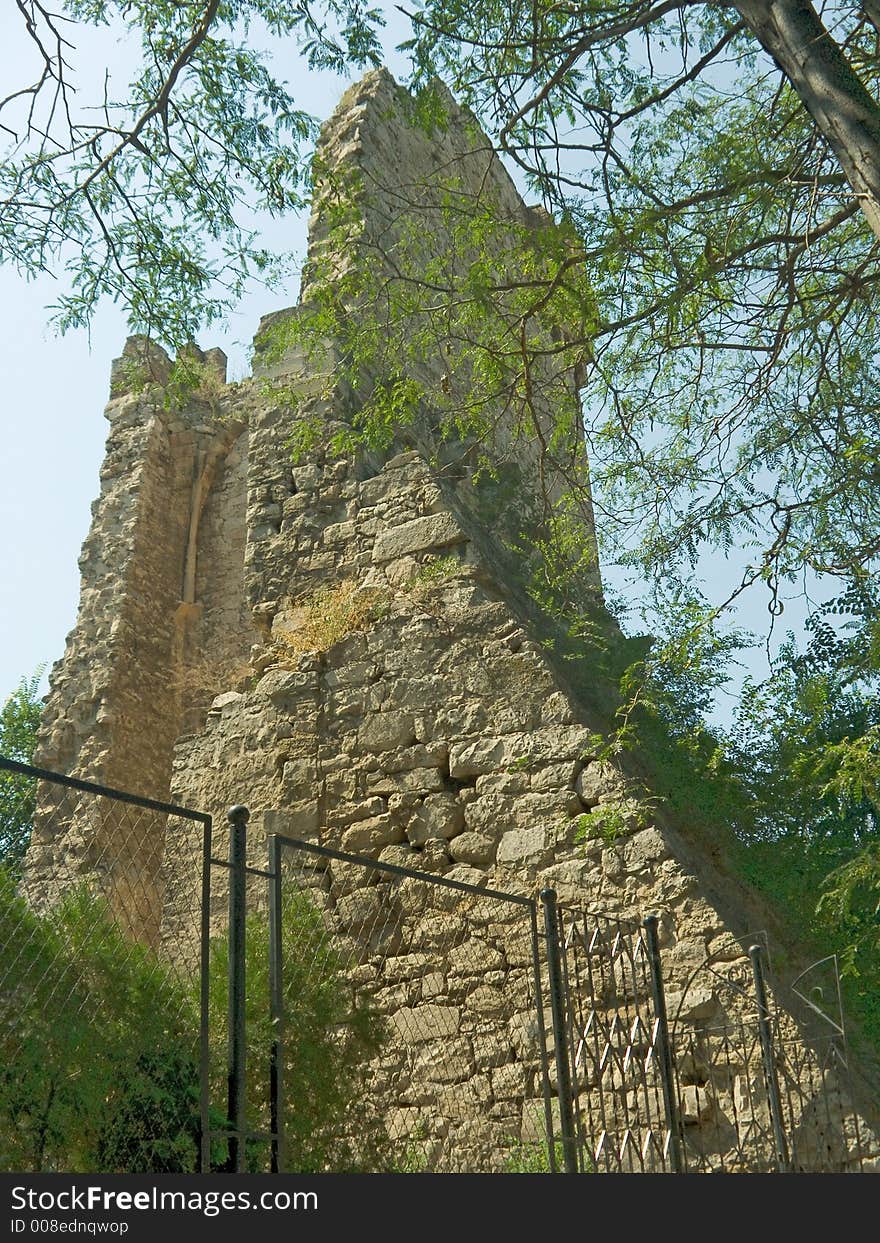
[264,839,554,1172]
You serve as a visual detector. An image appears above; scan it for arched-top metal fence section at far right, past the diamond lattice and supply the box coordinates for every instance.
[671,933,879,1173]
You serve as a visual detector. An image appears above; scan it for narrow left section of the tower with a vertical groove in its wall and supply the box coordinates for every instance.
[25,338,255,938]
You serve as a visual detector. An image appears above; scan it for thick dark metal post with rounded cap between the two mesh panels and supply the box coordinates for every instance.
[226,804,251,1173]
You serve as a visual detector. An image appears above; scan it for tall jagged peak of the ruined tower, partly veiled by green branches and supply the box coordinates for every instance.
[255,70,599,587]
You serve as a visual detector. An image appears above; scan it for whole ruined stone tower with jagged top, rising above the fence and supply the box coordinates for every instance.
[25,71,879,1173]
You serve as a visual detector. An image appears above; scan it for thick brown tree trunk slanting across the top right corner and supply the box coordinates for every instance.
[731,0,880,239]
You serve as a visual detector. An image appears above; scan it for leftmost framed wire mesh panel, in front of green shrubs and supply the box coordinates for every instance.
[0,758,210,1172]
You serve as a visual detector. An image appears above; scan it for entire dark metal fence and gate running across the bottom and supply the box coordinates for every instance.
[0,757,880,1172]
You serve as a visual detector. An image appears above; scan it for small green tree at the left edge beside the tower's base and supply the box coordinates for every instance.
[0,666,42,876]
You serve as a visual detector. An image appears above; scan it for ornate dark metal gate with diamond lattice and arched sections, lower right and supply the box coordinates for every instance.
[546,909,880,1173]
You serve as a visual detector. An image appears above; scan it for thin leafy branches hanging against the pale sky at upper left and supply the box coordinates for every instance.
[0,0,378,346]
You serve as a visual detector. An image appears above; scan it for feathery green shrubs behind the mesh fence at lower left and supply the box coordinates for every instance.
[0,869,390,1173]
